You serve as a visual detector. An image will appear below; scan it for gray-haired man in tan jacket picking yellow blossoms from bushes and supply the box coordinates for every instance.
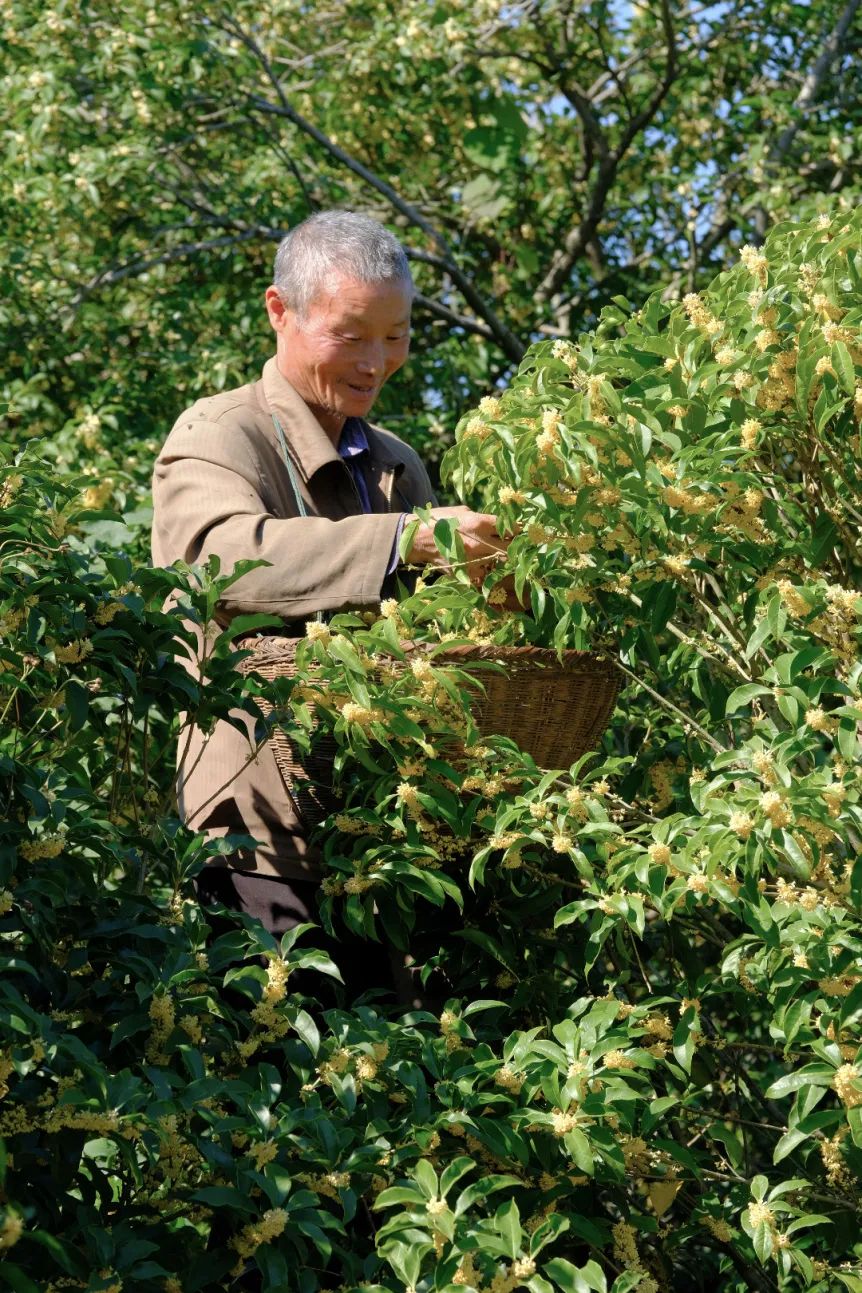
[152,211,504,956]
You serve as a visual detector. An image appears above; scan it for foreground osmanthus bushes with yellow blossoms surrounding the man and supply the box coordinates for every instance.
[0,211,862,1293]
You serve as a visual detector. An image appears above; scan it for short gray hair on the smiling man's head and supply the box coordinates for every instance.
[273,211,414,319]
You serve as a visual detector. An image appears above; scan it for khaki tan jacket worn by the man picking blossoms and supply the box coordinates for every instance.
[152,359,434,878]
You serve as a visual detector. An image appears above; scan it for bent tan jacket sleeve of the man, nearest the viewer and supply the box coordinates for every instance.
[152,422,408,619]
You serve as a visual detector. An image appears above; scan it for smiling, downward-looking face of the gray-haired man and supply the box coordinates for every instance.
[268,274,411,432]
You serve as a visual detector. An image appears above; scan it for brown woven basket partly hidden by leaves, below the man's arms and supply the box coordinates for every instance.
[239,636,620,825]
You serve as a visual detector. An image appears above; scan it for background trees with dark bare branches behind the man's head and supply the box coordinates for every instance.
[0,0,861,500]
